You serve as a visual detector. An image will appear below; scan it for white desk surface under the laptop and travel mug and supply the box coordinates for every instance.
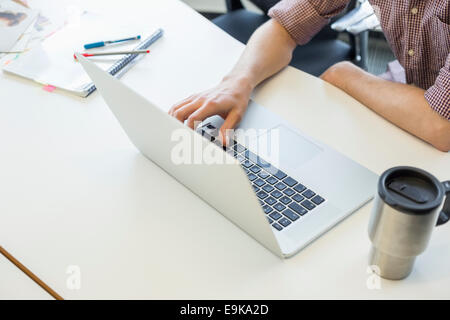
[0,0,450,299]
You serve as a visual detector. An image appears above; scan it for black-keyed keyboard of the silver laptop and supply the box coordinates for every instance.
[201,124,325,231]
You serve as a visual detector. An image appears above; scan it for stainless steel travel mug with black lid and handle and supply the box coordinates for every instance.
[369,167,450,280]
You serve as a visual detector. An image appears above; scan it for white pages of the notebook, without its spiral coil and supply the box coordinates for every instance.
[3,12,155,97]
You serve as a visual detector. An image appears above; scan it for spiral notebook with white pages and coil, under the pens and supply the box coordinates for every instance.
[3,11,163,97]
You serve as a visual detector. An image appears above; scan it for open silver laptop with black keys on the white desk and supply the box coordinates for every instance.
[77,55,378,258]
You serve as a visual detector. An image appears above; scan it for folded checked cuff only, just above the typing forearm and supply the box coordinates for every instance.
[269,0,329,45]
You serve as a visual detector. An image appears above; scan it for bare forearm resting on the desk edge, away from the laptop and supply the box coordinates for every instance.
[321,63,450,152]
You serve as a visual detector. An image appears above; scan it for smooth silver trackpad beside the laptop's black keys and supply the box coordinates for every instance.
[253,125,322,169]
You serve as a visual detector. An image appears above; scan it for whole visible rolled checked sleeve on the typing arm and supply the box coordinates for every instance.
[269,0,349,45]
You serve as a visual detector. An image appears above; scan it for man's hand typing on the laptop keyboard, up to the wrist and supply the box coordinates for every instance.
[169,77,253,144]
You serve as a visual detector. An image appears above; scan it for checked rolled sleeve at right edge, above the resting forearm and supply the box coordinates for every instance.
[425,54,450,120]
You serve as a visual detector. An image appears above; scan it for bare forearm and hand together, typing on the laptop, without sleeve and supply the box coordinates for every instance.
[169,19,296,143]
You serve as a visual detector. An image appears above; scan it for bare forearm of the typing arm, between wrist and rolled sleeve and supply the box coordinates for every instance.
[225,19,296,90]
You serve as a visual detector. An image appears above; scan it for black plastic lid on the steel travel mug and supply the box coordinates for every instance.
[378,167,444,214]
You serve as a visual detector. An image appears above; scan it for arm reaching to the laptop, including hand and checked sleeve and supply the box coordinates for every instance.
[169,0,350,143]
